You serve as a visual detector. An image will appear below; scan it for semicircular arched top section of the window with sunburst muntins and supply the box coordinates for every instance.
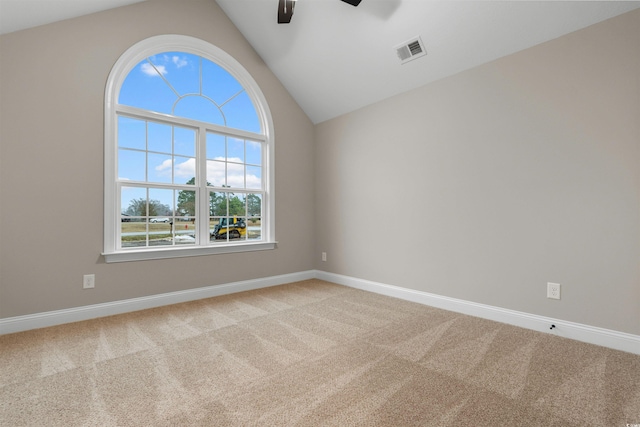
[106,34,273,137]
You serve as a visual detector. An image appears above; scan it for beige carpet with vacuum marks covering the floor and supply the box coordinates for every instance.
[0,280,640,427]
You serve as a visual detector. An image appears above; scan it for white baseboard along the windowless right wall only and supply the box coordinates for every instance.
[315,271,640,354]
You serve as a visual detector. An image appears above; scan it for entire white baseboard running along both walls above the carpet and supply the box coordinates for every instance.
[0,270,640,354]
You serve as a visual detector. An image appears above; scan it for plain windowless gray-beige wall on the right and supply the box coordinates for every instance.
[315,11,640,334]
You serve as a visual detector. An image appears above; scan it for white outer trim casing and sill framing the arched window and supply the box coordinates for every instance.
[102,34,277,263]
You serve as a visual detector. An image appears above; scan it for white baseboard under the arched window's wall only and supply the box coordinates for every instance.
[0,270,316,335]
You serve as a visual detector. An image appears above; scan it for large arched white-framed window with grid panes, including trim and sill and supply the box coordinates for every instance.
[104,35,275,262]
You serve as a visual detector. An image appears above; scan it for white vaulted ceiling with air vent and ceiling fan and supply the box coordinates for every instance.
[0,0,640,123]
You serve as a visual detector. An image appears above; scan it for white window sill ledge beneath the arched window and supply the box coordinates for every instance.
[102,242,277,264]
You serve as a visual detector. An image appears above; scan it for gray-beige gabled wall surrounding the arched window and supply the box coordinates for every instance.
[0,0,314,318]
